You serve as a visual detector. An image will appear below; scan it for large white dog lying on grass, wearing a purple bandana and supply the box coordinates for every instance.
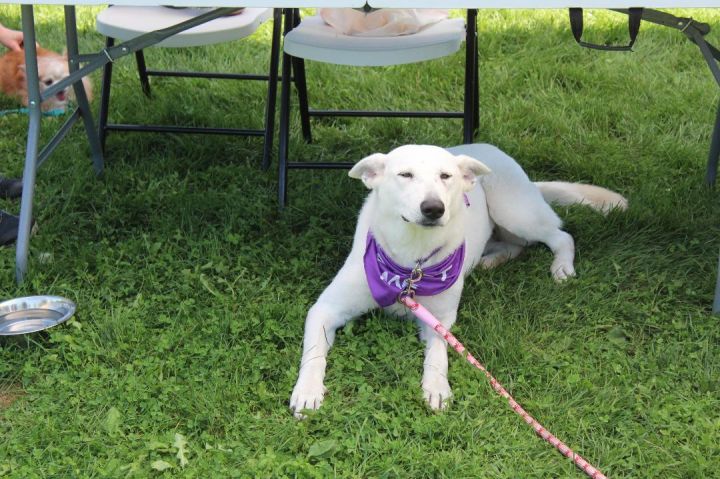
[290,144,627,417]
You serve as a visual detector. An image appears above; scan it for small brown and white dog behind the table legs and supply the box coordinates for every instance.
[0,47,92,111]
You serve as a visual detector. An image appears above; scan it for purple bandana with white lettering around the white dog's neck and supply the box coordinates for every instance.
[364,231,465,308]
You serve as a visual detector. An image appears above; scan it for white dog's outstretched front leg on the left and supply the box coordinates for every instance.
[290,268,375,419]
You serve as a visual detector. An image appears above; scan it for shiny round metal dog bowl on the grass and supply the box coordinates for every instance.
[0,296,76,336]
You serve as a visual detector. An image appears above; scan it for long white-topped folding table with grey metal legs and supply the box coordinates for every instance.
[7,0,720,313]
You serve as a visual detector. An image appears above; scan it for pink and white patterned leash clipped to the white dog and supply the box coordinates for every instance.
[398,296,607,479]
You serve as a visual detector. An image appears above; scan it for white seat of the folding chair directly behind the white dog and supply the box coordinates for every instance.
[283,16,465,66]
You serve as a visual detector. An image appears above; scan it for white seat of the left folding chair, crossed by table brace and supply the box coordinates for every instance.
[95,6,272,47]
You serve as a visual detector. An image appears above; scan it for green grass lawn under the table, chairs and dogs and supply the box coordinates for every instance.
[0,6,720,479]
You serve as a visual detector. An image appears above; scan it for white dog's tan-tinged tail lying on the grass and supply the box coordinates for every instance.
[535,181,628,215]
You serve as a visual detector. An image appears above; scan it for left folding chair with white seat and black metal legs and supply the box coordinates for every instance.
[95,6,282,169]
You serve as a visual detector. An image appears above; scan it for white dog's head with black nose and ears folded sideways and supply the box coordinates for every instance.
[349,145,490,227]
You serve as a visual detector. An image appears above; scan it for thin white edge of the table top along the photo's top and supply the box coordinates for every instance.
[8,0,720,9]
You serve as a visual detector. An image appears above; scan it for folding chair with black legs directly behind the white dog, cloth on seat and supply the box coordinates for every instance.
[278,9,479,207]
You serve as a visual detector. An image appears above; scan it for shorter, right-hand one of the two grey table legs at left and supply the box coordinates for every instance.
[65,5,105,174]
